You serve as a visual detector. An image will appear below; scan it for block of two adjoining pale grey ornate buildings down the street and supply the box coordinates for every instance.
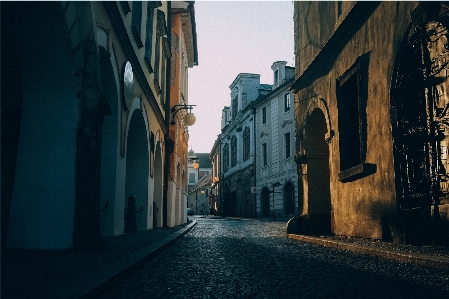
[217,61,298,217]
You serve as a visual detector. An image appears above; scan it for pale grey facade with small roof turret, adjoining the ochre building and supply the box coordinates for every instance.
[253,61,298,218]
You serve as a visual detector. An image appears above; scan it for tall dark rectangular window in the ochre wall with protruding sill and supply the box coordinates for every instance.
[337,60,364,177]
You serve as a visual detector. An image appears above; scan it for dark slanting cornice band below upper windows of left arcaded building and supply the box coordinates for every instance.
[103,1,168,134]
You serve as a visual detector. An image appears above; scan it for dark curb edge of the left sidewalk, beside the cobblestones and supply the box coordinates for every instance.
[43,220,197,299]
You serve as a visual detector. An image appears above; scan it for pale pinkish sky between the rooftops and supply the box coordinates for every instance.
[188,0,295,153]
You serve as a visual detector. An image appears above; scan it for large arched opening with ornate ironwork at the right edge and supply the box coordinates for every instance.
[391,2,449,244]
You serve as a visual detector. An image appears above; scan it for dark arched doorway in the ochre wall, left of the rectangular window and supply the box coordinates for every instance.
[303,108,331,236]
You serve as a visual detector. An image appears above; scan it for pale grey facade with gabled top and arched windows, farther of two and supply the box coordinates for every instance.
[220,73,271,217]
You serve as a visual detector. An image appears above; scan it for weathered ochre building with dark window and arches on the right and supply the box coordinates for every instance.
[292,1,449,243]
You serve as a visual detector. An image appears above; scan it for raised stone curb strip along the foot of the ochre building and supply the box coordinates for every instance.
[287,234,449,271]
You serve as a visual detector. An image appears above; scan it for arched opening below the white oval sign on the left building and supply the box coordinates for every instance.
[125,108,149,230]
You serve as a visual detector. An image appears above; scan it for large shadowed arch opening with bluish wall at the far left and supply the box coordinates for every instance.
[2,2,79,249]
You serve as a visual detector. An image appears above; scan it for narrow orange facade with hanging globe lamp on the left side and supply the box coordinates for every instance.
[164,1,198,227]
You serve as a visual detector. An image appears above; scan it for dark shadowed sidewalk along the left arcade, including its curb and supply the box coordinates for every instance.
[1,220,197,299]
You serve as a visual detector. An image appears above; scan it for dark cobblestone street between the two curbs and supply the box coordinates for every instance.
[96,219,449,298]
